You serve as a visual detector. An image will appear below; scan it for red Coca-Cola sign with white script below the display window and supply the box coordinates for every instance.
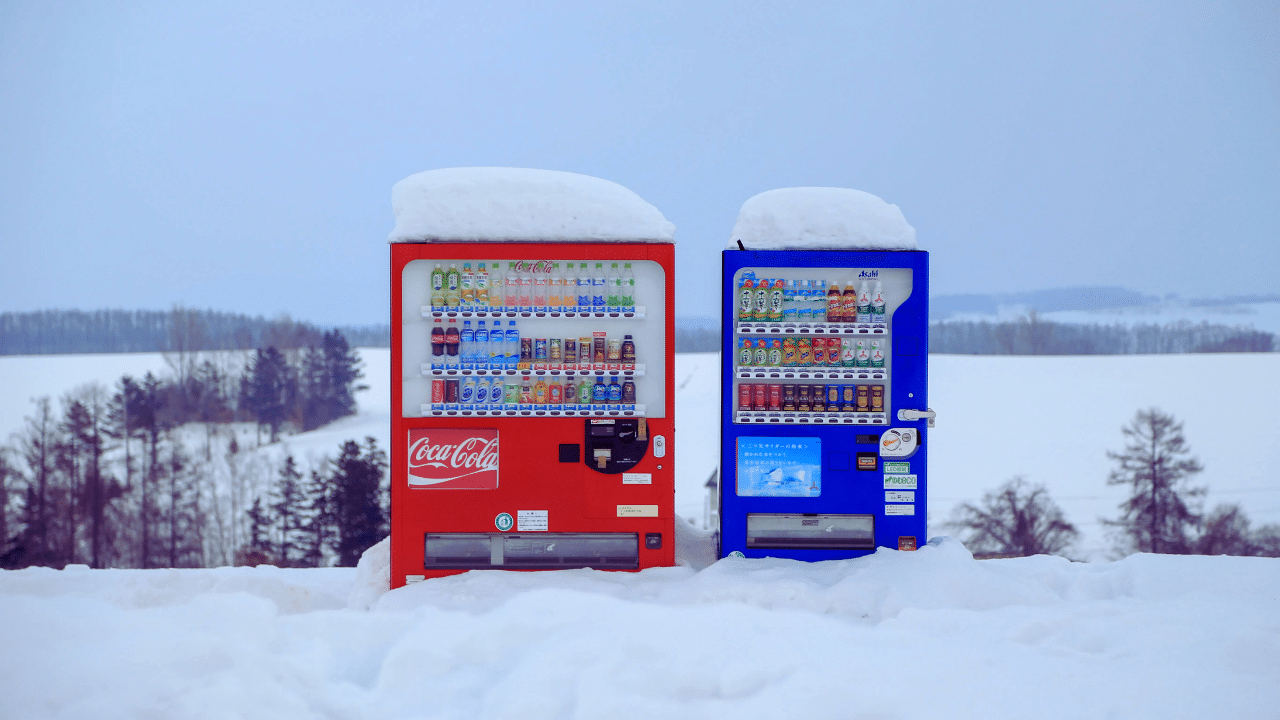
[408,428,498,489]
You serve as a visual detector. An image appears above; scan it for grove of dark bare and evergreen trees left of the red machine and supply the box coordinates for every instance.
[0,331,387,568]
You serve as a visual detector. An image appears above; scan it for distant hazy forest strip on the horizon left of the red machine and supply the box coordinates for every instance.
[0,306,390,355]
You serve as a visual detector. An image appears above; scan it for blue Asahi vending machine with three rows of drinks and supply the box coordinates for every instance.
[719,250,933,560]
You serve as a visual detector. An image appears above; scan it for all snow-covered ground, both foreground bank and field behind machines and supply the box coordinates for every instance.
[0,348,1280,720]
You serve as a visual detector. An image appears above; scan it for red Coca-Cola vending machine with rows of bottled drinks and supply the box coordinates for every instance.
[390,170,675,588]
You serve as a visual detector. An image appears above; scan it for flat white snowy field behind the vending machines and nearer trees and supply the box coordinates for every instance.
[0,348,1280,560]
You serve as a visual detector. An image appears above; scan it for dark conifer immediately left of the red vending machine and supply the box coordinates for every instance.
[332,437,387,568]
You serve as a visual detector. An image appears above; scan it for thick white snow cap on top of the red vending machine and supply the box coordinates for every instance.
[389,168,676,242]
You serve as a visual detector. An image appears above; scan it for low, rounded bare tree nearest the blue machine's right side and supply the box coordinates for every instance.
[945,477,1080,557]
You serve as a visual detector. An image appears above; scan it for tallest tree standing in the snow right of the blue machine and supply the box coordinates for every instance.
[1103,407,1204,555]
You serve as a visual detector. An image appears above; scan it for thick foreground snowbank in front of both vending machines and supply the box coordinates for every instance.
[0,541,1280,720]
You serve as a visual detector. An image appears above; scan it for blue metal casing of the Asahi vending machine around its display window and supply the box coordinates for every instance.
[719,250,929,560]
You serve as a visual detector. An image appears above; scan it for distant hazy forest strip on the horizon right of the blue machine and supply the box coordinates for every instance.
[929,310,1276,355]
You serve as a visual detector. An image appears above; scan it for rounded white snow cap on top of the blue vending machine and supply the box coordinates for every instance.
[727,187,916,250]
